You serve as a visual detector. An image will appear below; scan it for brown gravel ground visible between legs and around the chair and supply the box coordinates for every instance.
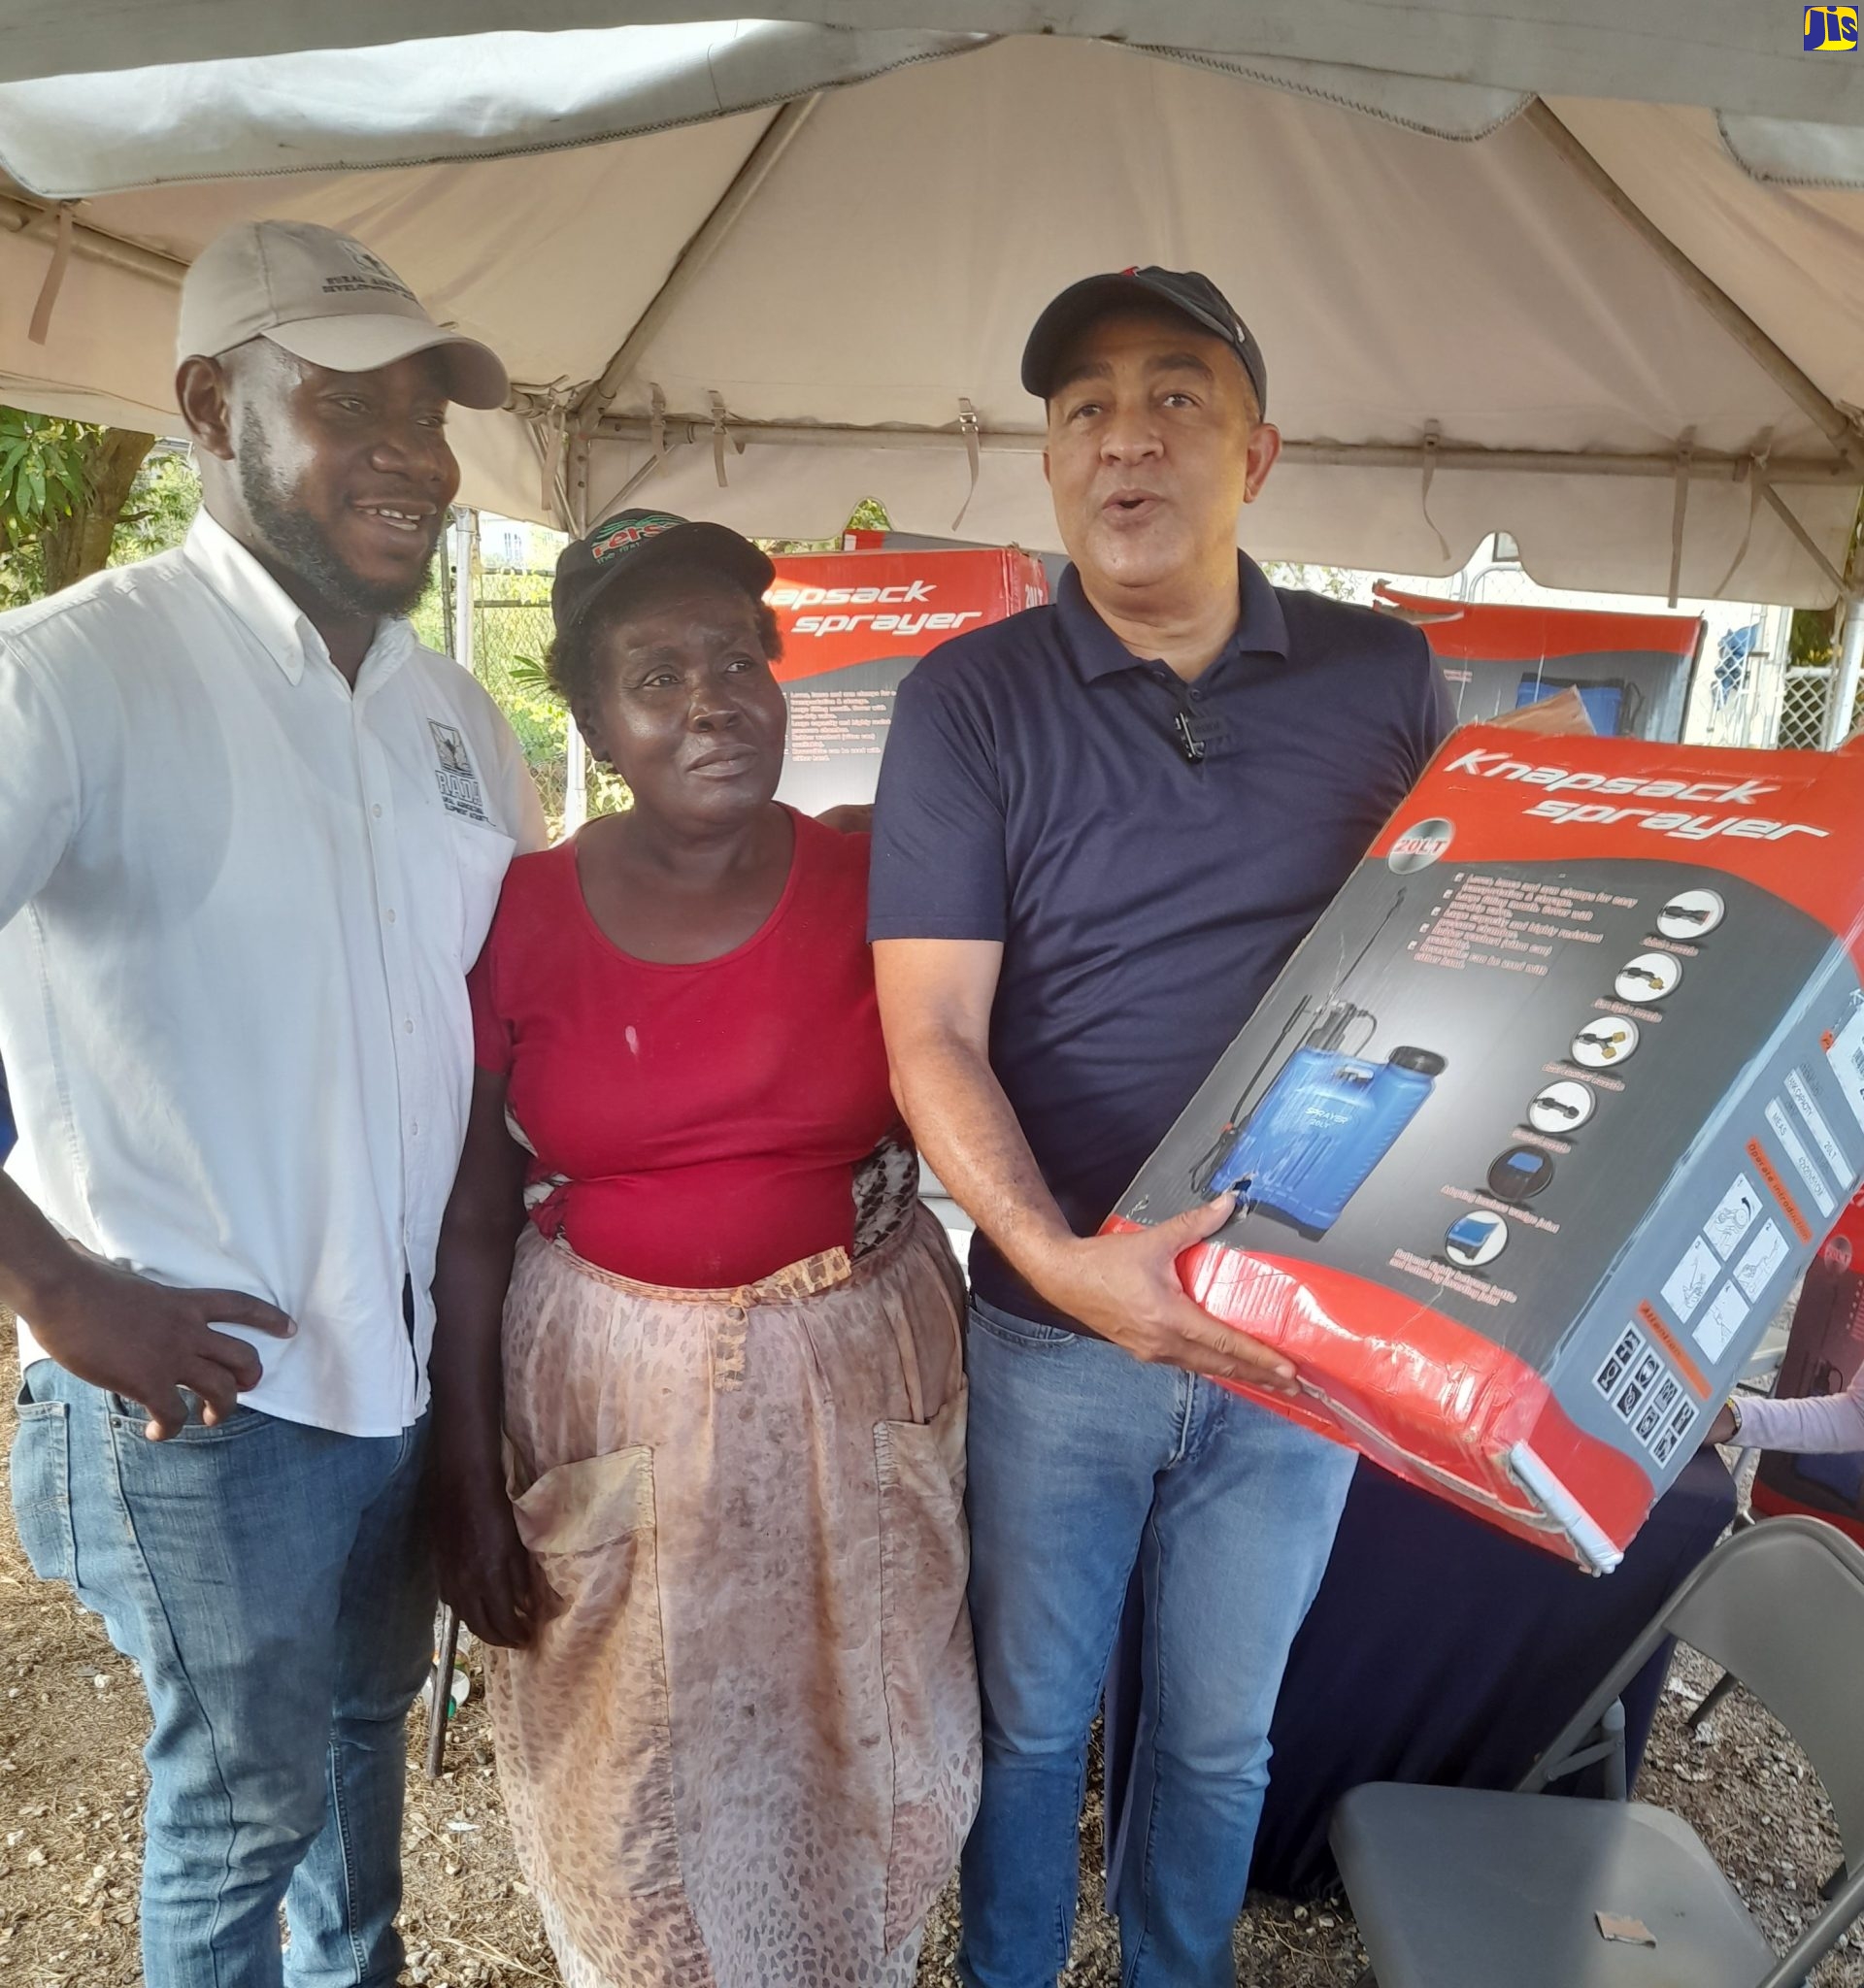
[0,1332,1864,1988]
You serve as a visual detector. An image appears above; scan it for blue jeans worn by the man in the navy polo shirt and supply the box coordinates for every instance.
[958,1300,1353,1988]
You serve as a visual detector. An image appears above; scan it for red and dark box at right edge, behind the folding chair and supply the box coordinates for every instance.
[1752,1195,1864,1546]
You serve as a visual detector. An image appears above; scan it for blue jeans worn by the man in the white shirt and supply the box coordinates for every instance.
[12,1360,433,1988]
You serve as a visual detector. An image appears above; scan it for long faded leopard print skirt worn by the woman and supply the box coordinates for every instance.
[489,1203,978,1988]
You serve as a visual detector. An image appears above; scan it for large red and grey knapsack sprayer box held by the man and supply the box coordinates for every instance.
[1109,726,1864,1573]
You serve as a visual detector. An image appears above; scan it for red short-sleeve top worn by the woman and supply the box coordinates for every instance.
[471,815,896,1290]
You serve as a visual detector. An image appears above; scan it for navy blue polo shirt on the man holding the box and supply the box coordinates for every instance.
[868,554,1450,1324]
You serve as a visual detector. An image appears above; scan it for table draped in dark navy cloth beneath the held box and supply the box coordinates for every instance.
[1107,1449,1735,1897]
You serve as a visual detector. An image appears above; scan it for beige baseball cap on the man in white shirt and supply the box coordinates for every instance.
[175,220,511,408]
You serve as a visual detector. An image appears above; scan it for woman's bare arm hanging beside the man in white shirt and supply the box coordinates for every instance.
[429,1070,537,1648]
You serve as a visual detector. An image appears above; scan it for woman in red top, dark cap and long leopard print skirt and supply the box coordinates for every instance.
[422,511,978,1988]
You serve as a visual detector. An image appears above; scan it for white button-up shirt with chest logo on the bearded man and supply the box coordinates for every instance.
[0,513,545,1436]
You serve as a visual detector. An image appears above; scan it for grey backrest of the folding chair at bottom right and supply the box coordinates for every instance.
[1663,1517,1864,1871]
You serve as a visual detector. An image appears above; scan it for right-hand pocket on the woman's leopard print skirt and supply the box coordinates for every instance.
[875,1385,980,1952]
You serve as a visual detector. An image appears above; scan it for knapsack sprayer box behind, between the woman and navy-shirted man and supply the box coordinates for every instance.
[765,547,1049,815]
